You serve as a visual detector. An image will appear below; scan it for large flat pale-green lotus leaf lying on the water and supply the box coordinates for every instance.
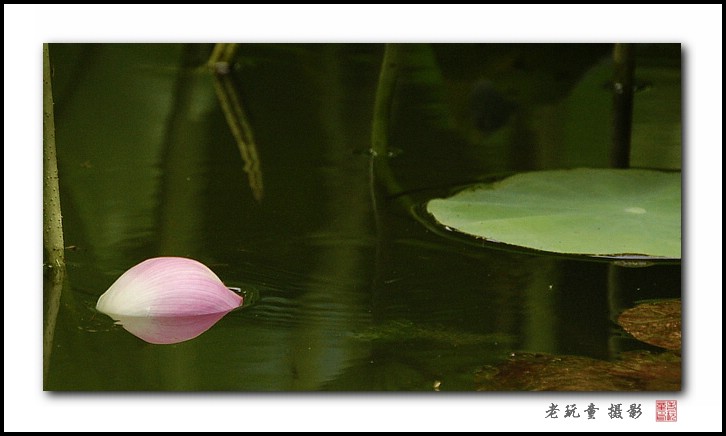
[427,168,681,259]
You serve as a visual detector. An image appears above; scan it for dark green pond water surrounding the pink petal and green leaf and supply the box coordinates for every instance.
[45,44,681,391]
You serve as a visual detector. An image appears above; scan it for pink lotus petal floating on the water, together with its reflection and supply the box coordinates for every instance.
[96,257,242,344]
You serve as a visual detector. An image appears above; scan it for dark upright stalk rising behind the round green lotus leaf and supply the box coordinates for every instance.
[610,44,635,168]
